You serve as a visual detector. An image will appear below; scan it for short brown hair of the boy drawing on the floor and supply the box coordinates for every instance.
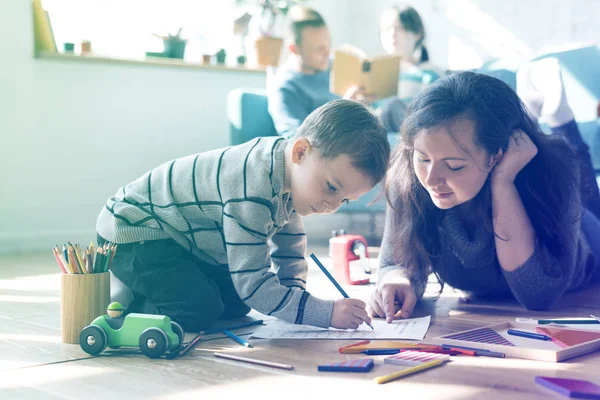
[294,100,390,184]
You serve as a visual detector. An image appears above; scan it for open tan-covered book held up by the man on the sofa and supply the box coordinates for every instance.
[329,44,400,99]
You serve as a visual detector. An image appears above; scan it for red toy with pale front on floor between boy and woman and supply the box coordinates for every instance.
[329,235,371,285]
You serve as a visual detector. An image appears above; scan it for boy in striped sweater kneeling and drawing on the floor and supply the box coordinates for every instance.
[96,100,390,332]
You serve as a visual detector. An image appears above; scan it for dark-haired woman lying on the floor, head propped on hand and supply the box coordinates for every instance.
[368,72,600,321]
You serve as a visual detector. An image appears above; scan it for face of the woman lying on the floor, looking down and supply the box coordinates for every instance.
[413,118,496,209]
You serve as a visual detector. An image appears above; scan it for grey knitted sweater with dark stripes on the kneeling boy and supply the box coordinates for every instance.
[96,137,333,327]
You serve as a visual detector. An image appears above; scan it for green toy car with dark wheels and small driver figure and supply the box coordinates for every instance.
[79,303,183,358]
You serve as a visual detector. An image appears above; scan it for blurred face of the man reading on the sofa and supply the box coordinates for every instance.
[292,26,331,72]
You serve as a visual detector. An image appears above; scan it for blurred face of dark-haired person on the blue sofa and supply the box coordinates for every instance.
[379,10,420,58]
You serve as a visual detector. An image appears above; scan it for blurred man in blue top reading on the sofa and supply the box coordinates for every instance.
[267,6,365,137]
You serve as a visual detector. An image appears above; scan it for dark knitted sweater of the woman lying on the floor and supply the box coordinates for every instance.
[379,177,600,310]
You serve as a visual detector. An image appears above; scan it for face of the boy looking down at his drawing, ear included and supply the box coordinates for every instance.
[288,138,374,216]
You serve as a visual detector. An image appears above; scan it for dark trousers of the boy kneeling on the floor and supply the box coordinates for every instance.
[98,236,250,332]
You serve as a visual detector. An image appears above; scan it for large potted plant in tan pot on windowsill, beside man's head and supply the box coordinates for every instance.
[234,0,303,67]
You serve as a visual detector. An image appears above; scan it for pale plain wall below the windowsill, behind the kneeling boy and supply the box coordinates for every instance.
[0,0,265,252]
